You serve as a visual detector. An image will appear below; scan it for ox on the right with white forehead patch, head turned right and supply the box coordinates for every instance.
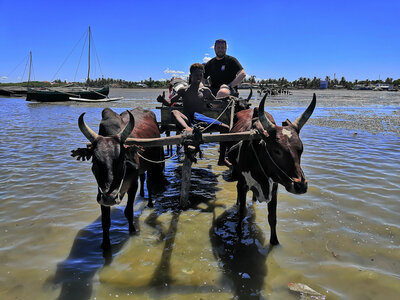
[228,94,316,245]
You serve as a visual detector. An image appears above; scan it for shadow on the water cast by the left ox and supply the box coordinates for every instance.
[46,208,137,300]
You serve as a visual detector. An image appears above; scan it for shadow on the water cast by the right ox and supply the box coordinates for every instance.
[209,206,271,299]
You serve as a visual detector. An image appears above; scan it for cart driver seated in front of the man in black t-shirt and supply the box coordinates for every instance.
[157,63,230,166]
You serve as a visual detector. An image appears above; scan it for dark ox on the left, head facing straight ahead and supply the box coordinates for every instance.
[75,108,164,248]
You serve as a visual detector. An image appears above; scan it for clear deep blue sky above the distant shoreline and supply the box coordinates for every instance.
[0,0,400,82]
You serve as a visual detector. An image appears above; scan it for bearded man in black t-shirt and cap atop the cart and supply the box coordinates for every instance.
[204,39,246,98]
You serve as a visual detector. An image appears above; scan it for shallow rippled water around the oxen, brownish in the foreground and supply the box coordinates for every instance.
[0,89,400,299]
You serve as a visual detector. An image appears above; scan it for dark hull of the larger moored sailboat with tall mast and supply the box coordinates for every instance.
[26,86,110,102]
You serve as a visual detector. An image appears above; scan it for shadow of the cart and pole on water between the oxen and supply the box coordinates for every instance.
[114,165,227,298]
